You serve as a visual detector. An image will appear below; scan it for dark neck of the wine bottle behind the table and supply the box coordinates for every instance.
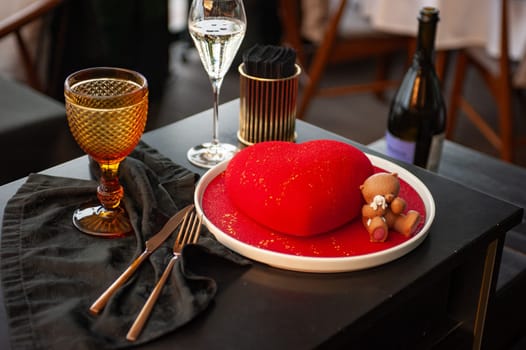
[414,7,439,65]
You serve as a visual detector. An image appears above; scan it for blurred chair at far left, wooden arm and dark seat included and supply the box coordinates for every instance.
[0,0,82,184]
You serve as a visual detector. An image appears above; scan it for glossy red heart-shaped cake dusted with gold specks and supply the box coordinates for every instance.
[224,140,373,236]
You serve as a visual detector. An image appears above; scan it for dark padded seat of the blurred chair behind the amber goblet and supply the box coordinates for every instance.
[0,77,83,184]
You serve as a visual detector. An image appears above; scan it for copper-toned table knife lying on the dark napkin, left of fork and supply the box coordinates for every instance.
[89,204,194,315]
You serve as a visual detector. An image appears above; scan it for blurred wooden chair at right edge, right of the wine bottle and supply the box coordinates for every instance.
[446,0,515,162]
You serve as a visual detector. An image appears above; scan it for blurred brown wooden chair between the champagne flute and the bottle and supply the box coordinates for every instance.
[279,0,416,118]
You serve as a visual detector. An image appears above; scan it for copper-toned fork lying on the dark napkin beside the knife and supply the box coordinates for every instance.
[126,209,201,341]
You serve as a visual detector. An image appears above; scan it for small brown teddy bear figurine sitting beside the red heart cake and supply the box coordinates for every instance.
[360,173,420,242]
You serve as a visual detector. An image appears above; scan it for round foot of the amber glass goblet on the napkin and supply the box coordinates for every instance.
[73,205,132,238]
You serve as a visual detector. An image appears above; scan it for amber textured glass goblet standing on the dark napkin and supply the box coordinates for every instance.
[64,67,148,237]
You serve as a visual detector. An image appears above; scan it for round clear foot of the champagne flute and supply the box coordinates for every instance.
[186,142,238,168]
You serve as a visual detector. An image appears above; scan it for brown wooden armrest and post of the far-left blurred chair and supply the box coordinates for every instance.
[0,0,62,91]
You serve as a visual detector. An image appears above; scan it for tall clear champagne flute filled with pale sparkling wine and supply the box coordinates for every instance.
[187,0,246,168]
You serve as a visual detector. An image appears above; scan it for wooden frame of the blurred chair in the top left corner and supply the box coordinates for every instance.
[0,0,62,91]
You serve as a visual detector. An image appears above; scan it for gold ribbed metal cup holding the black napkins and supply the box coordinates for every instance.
[237,63,301,146]
